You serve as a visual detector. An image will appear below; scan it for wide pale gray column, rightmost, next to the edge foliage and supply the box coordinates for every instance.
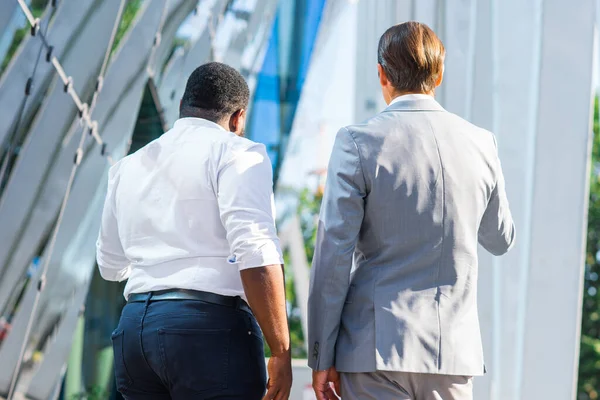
[517,0,596,400]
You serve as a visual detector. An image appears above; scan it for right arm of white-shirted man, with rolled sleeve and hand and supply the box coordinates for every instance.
[217,145,292,400]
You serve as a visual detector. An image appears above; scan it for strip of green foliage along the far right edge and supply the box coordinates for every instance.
[578,98,600,400]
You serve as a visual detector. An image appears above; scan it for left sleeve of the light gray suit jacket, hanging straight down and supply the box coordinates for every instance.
[308,128,366,370]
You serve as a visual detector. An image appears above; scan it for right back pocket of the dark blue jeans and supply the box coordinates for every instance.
[158,329,231,393]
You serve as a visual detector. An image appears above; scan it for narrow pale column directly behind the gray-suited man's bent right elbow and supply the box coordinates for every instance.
[490,0,542,399]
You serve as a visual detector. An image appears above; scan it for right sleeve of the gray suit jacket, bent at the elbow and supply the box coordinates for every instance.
[479,139,515,256]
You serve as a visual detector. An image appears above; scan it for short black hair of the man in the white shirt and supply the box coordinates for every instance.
[179,62,250,122]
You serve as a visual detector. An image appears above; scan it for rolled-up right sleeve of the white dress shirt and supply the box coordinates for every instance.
[217,144,283,270]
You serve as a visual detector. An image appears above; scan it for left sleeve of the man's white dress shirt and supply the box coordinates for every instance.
[96,165,131,282]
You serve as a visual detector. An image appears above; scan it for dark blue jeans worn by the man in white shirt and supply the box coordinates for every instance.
[112,300,266,400]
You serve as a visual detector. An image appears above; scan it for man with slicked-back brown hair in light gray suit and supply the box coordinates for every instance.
[308,22,515,400]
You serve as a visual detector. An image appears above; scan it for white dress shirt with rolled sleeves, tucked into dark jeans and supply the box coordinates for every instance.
[97,118,283,298]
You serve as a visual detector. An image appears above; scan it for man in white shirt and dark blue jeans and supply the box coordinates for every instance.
[97,63,292,400]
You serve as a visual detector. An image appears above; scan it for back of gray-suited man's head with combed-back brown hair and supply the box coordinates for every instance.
[377,21,446,93]
